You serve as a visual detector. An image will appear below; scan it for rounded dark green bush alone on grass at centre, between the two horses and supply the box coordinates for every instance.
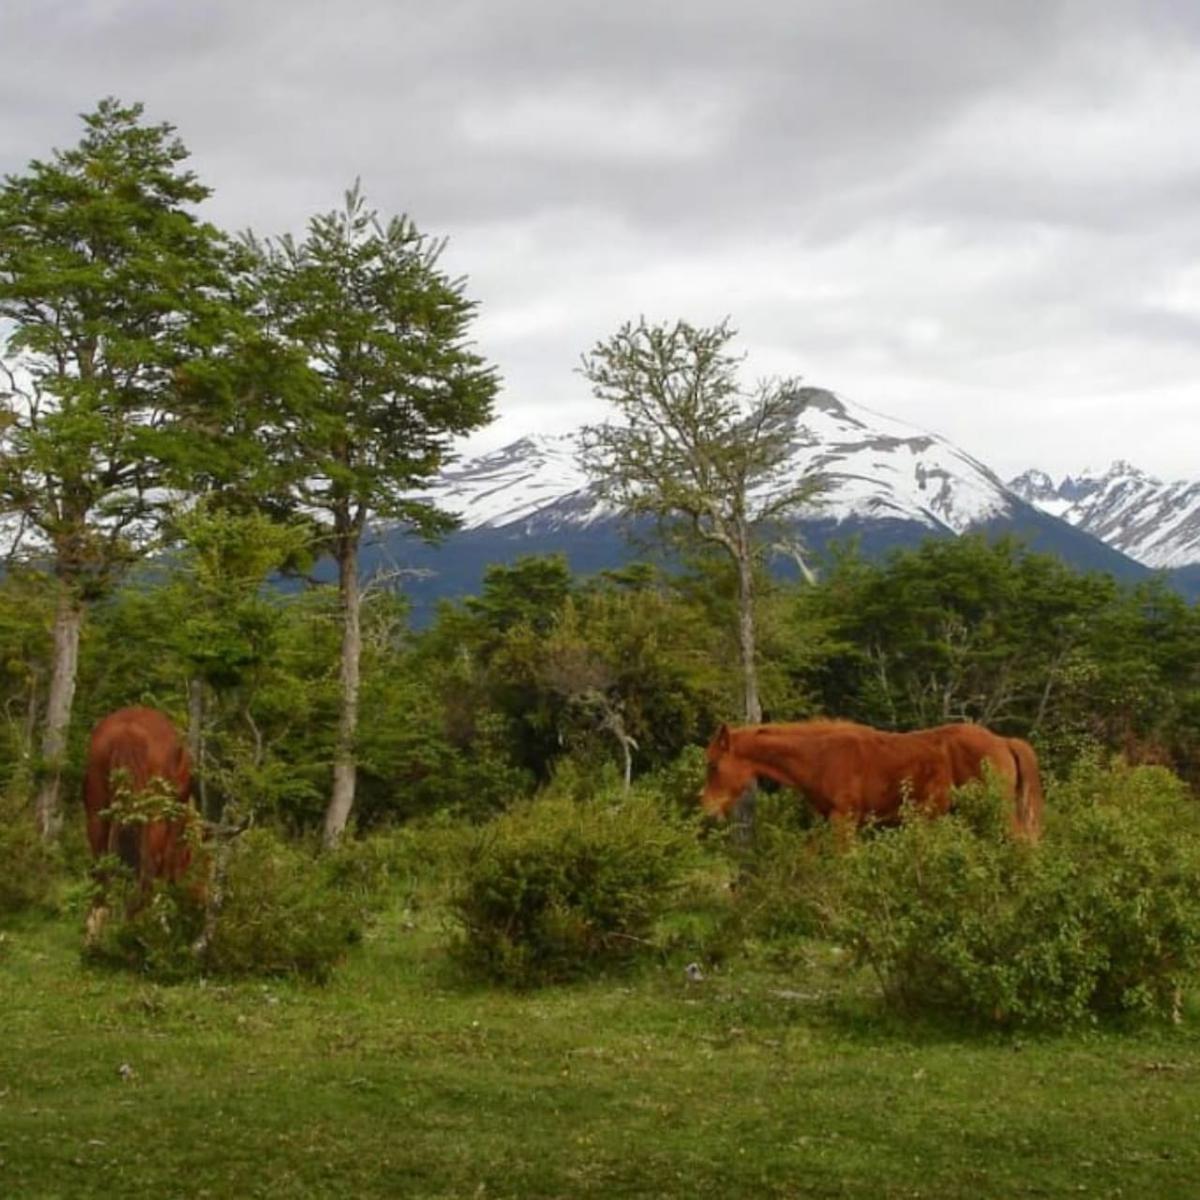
[451,790,695,985]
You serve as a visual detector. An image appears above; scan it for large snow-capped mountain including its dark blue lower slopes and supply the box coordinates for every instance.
[364,388,1180,622]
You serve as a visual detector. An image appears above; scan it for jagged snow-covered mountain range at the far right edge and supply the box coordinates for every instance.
[1008,462,1200,569]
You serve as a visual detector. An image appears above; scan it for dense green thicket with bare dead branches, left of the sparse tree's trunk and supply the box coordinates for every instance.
[414,556,726,780]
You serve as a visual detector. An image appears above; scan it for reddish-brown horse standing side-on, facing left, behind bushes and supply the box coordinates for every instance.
[701,721,1042,839]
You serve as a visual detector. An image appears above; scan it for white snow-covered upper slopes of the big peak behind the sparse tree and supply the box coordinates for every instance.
[426,388,1020,534]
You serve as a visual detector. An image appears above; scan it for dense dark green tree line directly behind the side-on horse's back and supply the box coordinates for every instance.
[793,535,1200,769]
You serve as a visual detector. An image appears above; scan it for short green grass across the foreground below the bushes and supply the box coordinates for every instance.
[0,911,1200,1200]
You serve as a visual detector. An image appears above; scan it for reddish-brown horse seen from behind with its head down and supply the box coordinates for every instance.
[83,708,196,937]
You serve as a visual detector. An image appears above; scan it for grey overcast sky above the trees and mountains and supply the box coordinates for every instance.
[0,0,1200,479]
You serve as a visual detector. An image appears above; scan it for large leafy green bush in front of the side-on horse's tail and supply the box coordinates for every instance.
[830,760,1200,1025]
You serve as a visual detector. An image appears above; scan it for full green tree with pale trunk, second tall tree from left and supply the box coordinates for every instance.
[248,184,497,845]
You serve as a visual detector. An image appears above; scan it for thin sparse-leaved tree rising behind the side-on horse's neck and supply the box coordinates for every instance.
[582,318,821,722]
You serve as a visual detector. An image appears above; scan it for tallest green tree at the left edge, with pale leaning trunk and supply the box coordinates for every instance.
[0,98,241,836]
